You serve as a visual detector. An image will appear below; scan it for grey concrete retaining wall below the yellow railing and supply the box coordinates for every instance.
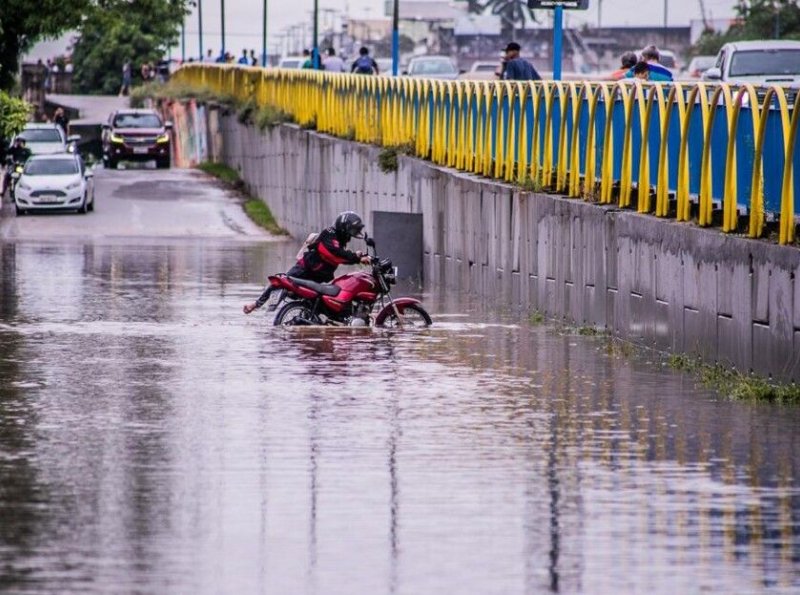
[202,110,800,380]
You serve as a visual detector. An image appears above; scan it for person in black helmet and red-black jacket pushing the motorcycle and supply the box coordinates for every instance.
[242,211,371,314]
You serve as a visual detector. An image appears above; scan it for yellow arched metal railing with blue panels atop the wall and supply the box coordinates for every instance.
[173,65,800,244]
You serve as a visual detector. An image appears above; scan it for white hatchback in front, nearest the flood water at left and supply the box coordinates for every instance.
[12,153,94,215]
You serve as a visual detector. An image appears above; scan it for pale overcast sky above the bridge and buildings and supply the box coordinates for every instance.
[175,0,736,55]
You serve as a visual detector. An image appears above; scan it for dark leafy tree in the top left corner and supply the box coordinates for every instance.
[0,0,92,90]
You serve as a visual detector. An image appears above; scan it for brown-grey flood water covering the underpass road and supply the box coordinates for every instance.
[0,241,800,594]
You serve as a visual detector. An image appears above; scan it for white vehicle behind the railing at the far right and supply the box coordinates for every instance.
[703,40,800,86]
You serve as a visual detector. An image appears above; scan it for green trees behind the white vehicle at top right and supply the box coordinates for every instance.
[692,0,800,56]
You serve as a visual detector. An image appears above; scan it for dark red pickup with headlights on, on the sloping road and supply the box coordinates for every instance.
[103,109,172,169]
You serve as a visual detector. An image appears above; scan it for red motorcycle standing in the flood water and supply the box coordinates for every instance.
[269,237,432,328]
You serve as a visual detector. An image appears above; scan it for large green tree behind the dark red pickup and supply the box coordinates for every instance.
[72,0,186,94]
